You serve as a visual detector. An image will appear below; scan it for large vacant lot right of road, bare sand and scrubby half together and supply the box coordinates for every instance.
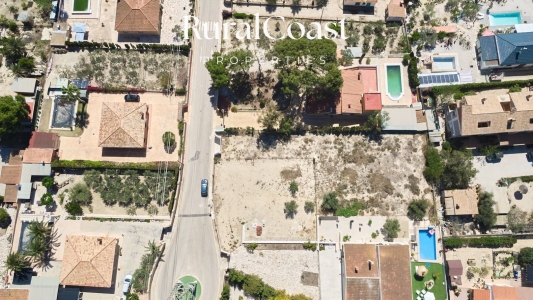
[214,135,430,251]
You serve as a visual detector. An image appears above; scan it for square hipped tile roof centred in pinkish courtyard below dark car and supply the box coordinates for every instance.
[98,102,149,148]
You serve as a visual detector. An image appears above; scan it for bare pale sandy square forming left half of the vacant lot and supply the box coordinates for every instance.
[213,158,315,250]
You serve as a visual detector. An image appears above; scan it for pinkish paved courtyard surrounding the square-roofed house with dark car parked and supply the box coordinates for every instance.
[59,93,182,162]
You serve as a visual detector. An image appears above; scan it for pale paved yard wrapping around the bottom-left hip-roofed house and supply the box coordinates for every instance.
[44,219,163,300]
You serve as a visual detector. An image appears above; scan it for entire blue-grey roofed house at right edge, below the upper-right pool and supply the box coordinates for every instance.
[476,32,533,70]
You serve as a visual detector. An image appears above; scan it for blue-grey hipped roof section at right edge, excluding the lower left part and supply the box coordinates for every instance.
[496,32,533,66]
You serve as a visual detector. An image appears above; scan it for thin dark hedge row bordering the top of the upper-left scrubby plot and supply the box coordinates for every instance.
[65,41,191,56]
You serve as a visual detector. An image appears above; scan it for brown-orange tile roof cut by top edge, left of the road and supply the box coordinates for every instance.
[115,0,161,34]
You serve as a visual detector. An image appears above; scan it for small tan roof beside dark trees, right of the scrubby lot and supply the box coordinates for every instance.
[444,187,479,215]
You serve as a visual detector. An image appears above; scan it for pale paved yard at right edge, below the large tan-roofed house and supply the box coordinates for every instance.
[473,146,533,191]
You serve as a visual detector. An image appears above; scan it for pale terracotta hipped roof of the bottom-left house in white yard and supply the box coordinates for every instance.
[59,235,117,288]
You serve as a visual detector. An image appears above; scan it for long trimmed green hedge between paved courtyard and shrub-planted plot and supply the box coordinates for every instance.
[52,160,179,171]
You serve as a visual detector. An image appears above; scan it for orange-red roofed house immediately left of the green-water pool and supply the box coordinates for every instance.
[306,66,382,115]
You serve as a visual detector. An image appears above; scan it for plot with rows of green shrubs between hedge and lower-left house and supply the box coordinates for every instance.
[58,170,175,215]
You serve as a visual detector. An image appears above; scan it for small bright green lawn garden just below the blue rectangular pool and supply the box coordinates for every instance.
[411,262,447,300]
